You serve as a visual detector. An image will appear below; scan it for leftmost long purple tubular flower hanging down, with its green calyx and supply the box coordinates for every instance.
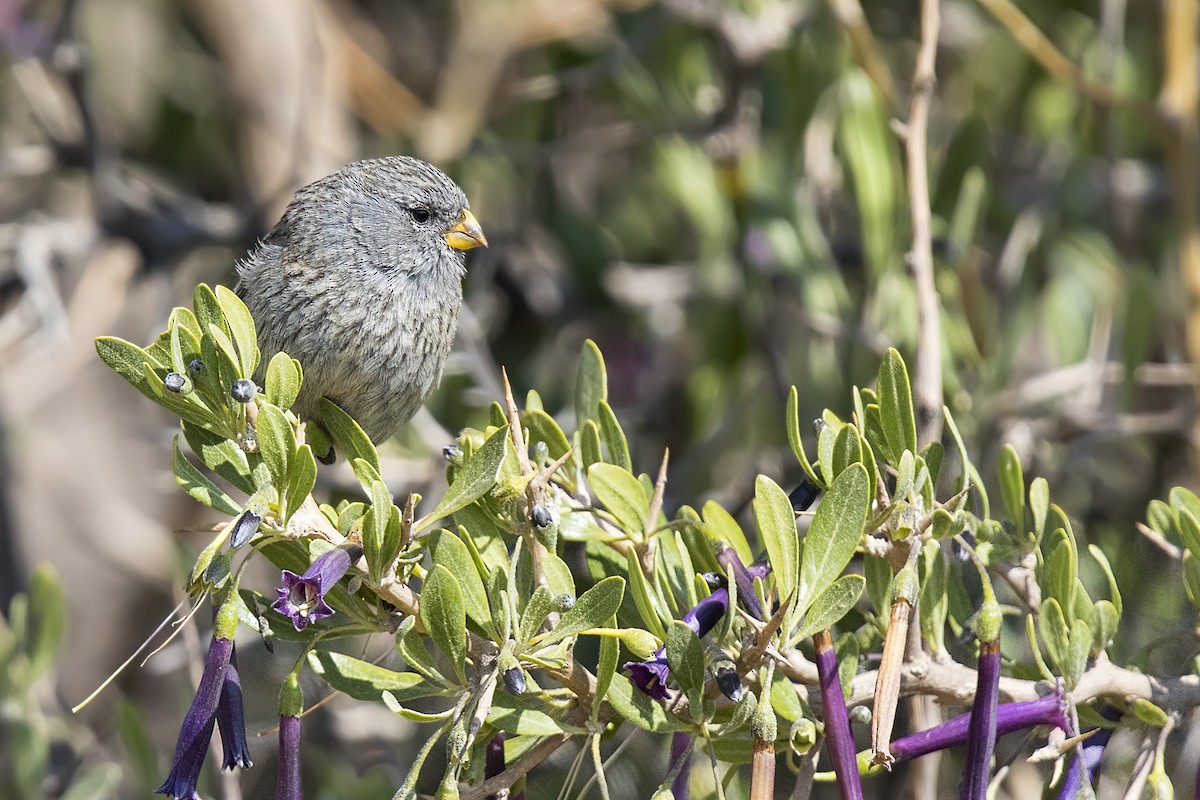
[155,601,238,800]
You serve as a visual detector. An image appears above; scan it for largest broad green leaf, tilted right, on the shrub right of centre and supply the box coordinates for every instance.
[796,464,870,614]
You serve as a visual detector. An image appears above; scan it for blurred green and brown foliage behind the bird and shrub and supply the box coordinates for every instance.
[0,0,1200,798]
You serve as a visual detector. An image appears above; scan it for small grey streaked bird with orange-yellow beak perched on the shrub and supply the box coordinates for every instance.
[234,156,487,450]
